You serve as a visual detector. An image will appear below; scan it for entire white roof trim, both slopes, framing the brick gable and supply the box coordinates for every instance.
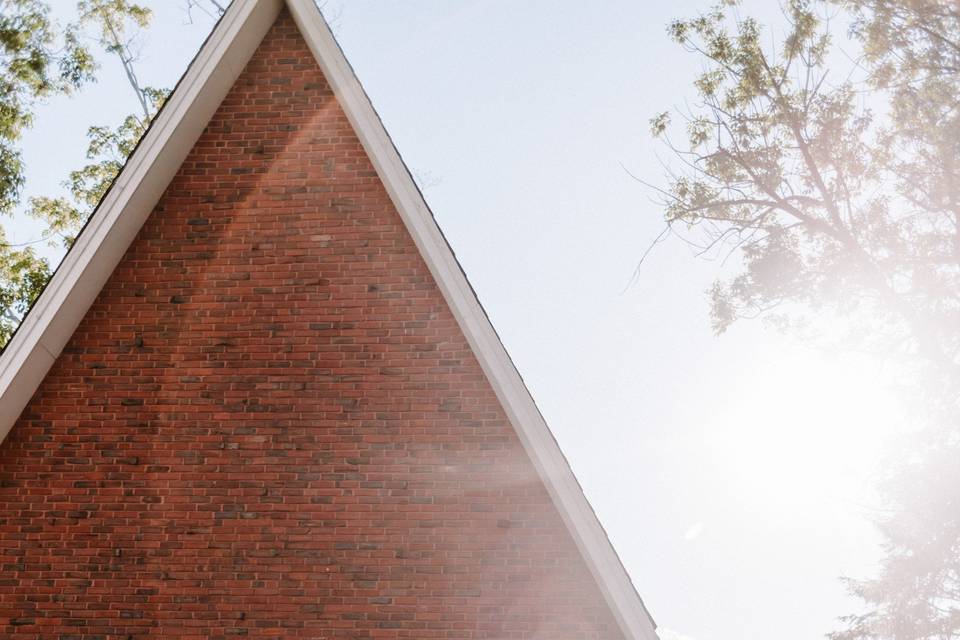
[0,0,657,640]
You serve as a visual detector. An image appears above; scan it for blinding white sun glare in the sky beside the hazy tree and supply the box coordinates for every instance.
[708,350,903,513]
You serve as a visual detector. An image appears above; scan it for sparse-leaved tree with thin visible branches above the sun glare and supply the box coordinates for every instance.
[653,0,960,376]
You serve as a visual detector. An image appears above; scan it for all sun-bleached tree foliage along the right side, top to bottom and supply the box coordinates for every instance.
[651,0,960,640]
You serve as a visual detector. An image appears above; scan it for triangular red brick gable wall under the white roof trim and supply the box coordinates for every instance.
[0,15,621,640]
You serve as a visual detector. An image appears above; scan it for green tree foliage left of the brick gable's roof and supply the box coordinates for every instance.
[0,0,174,345]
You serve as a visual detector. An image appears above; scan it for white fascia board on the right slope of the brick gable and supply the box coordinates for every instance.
[286,0,657,640]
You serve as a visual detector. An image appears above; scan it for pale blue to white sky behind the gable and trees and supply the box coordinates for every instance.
[11,0,899,640]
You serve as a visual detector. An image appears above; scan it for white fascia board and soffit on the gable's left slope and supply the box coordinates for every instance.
[0,0,283,441]
